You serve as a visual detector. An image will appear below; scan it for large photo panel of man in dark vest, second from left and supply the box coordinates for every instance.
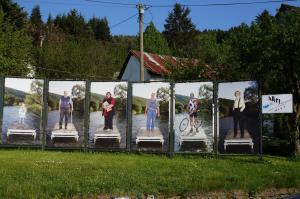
[46,81,85,147]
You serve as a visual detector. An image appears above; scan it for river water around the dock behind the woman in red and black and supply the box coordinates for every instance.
[89,111,127,149]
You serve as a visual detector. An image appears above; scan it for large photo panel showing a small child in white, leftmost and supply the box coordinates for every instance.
[1,78,44,145]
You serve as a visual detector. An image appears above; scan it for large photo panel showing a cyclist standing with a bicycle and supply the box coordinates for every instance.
[173,82,214,153]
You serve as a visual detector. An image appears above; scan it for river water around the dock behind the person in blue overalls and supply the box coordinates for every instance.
[131,114,169,152]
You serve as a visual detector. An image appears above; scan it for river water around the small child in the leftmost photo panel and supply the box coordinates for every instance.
[1,106,42,145]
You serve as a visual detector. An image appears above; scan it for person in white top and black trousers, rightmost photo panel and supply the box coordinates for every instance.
[233,91,246,138]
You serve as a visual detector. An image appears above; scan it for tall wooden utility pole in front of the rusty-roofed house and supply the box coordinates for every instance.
[137,3,145,81]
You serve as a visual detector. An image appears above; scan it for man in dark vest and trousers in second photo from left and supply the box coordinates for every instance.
[58,91,73,129]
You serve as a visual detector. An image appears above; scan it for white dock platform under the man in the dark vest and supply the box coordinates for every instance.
[51,124,79,142]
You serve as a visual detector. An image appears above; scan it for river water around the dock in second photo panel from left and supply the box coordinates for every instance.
[46,110,84,147]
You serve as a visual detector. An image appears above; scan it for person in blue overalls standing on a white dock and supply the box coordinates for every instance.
[145,93,160,131]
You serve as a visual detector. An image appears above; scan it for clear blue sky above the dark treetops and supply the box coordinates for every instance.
[15,0,300,35]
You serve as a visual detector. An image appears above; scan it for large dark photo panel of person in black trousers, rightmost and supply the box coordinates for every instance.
[218,81,261,154]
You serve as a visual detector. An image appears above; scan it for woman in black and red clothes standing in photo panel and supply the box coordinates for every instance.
[102,92,116,131]
